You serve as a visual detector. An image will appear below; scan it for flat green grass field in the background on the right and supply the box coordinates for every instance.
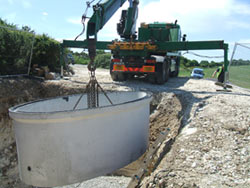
[179,65,250,89]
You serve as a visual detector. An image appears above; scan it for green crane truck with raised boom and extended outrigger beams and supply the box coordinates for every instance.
[61,0,228,84]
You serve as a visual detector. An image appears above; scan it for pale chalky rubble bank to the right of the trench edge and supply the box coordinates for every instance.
[141,80,250,188]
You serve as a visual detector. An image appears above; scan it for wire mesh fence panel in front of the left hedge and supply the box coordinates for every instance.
[0,25,35,77]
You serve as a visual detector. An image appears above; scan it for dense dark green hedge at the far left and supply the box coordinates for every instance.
[0,18,60,75]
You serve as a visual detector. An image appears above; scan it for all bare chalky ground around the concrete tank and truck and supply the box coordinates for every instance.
[0,65,250,188]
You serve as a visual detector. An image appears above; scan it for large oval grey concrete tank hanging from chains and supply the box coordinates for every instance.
[9,92,151,187]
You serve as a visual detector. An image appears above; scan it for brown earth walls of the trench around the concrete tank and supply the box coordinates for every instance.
[0,79,187,188]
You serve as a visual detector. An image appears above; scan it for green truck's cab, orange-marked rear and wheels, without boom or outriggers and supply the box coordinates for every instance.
[109,22,182,84]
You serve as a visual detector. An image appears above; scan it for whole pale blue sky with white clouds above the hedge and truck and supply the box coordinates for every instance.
[0,0,250,61]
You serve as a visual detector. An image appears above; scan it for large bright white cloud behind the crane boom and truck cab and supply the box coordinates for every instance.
[67,0,250,44]
